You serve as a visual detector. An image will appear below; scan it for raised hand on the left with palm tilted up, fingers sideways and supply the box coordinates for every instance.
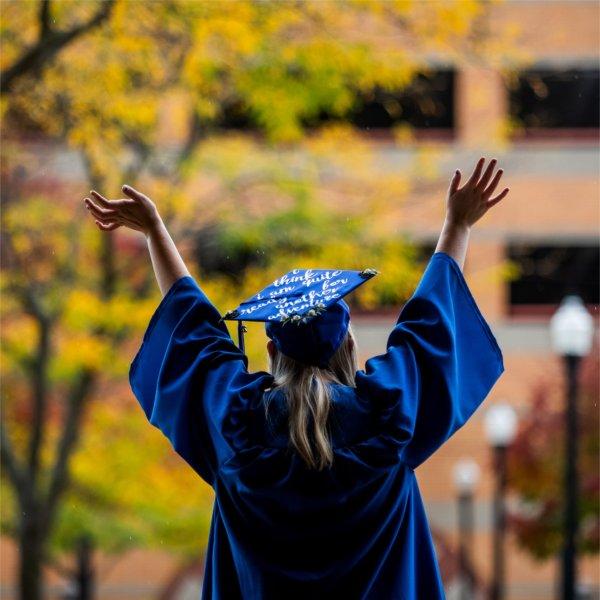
[83,185,161,235]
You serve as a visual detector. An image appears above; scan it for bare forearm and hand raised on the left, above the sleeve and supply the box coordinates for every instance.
[84,185,190,297]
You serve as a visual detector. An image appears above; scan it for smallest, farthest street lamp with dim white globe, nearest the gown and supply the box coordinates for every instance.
[453,458,479,600]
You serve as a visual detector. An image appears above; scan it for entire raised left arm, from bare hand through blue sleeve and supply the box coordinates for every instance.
[85,186,273,486]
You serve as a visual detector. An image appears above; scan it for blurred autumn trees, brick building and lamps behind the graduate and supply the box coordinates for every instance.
[0,0,600,600]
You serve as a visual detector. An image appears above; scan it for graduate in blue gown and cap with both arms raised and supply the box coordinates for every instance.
[85,157,509,600]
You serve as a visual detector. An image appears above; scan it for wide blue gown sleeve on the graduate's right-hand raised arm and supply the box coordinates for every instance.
[355,252,504,469]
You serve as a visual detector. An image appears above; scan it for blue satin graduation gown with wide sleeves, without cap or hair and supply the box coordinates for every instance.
[129,252,504,600]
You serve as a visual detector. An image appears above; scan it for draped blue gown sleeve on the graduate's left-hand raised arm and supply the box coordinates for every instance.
[129,275,272,486]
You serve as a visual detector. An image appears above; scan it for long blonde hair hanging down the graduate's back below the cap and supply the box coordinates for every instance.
[265,325,358,471]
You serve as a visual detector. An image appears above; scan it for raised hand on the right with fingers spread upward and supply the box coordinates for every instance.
[446,156,509,227]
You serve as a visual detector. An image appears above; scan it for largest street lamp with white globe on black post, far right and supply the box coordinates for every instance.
[550,295,594,600]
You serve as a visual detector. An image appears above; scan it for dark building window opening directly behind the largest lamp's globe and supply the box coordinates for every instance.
[508,243,600,316]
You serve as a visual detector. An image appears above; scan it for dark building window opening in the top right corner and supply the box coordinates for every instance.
[507,68,600,138]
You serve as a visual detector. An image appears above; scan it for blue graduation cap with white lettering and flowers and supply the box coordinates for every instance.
[221,269,378,367]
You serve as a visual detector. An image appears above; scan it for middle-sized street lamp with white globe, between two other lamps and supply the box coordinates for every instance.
[484,404,517,600]
